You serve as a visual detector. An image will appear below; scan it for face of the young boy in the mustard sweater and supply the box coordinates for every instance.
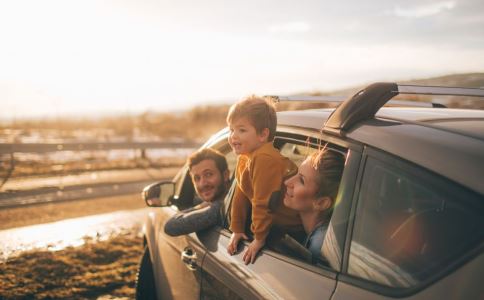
[229,117,269,155]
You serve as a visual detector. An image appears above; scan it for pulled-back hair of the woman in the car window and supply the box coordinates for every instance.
[309,148,345,204]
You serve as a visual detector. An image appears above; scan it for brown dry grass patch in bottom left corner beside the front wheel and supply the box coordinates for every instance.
[0,233,143,299]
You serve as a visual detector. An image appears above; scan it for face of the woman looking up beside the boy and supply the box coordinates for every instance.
[284,158,318,212]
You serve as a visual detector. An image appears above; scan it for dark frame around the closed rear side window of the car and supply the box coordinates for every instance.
[338,146,484,297]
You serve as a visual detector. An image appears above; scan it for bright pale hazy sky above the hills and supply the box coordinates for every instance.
[0,0,484,120]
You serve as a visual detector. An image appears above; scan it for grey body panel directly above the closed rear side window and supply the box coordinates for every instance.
[348,120,484,195]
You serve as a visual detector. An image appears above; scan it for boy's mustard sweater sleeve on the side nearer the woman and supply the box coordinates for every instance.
[251,155,285,240]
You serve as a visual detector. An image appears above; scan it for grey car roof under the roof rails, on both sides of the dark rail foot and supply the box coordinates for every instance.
[278,107,484,195]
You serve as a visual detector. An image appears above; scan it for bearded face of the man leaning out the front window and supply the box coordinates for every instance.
[190,159,225,202]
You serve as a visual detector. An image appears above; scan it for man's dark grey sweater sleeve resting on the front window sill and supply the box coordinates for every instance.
[165,200,222,236]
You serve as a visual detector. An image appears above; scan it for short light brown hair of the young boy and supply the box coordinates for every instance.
[227,95,277,142]
